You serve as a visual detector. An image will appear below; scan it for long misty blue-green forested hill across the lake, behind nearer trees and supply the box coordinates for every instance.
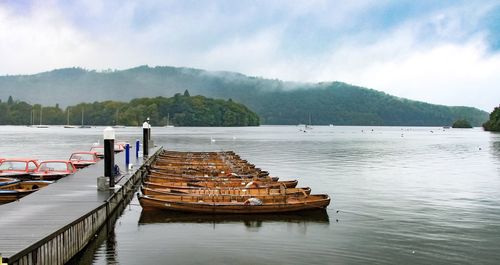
[0,66,488,126]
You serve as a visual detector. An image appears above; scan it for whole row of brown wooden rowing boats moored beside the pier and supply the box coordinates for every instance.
[138,151,330,214]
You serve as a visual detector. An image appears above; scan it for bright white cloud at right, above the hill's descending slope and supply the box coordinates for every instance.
[339,38,500,111]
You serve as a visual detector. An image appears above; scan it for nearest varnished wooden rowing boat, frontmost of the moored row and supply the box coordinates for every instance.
[138,194,330,214]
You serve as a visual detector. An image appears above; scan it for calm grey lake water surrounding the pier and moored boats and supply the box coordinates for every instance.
[0,126,500,264]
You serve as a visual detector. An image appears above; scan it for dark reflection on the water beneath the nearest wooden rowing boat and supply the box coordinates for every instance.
[139,209,330,230]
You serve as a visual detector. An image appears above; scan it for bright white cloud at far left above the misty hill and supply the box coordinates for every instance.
[0,3,94,73]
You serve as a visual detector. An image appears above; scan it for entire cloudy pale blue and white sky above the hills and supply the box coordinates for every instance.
[0,0,500,111]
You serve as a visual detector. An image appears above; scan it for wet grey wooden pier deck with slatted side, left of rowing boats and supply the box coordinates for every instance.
[0,145,161,265]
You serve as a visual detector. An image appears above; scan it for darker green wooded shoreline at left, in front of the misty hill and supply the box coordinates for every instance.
[0,90,260,126]
